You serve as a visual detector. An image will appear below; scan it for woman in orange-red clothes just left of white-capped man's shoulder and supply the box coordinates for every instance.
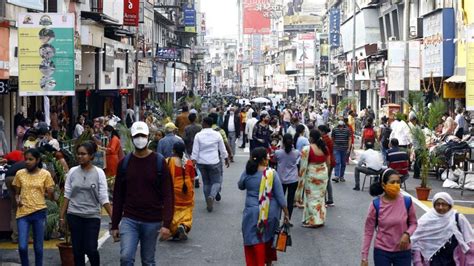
[104,125,123,176]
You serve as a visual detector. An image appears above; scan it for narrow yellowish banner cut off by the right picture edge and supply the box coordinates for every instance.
[466,24,474,111]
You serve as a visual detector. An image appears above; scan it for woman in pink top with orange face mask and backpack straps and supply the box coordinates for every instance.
[361,168,417,266]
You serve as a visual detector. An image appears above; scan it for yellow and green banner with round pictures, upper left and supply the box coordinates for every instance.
[18,13,75,96]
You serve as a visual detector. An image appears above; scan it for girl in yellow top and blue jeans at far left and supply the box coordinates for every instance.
[12,149,54,266]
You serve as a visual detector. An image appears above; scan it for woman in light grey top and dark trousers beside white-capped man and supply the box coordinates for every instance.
[59,141,112,266]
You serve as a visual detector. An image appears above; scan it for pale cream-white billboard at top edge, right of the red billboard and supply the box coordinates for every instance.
[283,0,325,31]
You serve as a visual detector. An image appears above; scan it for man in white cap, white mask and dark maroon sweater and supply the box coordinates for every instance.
[111,122,174,266]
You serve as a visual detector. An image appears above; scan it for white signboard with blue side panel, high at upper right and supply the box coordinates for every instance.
[423,8,455,78]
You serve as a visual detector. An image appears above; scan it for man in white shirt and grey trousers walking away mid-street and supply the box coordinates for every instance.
[191,117,229,212]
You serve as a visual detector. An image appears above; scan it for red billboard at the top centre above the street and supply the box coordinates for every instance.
[243,0,270,34]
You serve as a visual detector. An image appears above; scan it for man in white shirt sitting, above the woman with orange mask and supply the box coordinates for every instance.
[353,143,383,191]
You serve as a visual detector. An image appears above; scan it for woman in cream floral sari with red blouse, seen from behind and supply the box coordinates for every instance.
[296,129,331,228]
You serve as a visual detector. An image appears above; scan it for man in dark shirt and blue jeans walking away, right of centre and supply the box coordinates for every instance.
[331,119,351,183]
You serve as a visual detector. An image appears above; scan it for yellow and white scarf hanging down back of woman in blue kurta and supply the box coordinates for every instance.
[257,168,273,238]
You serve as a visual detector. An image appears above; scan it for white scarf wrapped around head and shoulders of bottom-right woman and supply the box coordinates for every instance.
[410,192,469,260]
